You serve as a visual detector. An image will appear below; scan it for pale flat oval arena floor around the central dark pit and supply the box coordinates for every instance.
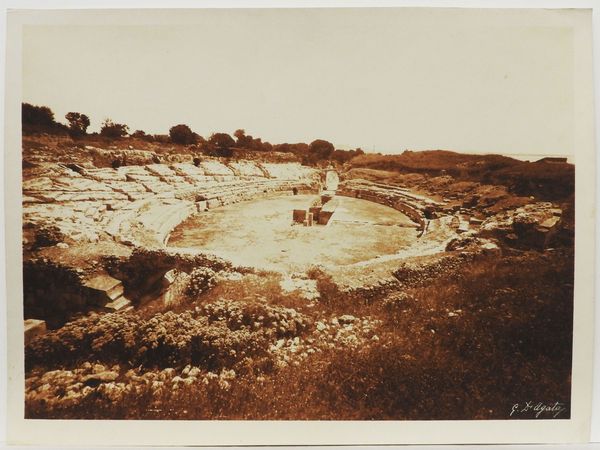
[168,195,417,272]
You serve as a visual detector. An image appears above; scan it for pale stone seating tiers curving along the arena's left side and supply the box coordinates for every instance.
[23,161,318,244]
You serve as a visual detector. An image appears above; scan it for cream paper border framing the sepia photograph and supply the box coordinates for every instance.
[4,3,596,445]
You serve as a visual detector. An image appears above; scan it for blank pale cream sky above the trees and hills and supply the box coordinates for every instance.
[23,9,573,155]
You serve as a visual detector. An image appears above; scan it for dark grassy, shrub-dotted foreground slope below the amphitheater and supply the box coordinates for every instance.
[26,250,573,420]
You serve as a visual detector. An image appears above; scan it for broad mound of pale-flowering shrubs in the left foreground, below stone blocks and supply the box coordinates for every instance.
[26,300,312,370]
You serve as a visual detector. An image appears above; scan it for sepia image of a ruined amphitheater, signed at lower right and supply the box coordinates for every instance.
[6,3,594,446]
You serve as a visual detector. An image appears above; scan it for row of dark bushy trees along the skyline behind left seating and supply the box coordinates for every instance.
[21,103,364,165]
